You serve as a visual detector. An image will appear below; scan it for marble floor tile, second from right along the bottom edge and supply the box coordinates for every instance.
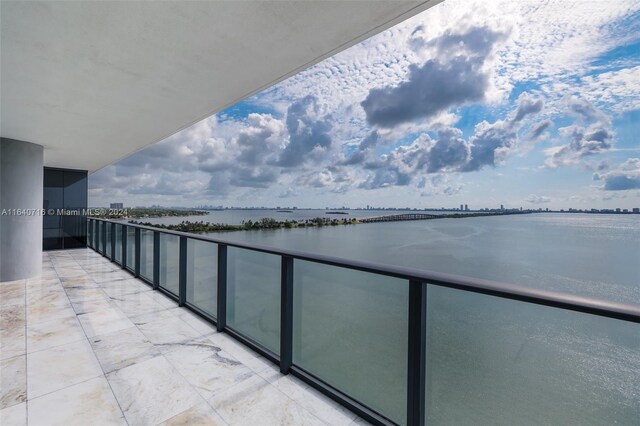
[209,375,325,425]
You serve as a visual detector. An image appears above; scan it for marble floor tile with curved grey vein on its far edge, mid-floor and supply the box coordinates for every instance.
[165,338,255,399]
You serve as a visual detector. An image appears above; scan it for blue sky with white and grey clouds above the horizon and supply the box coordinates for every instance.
[89,0,640,208]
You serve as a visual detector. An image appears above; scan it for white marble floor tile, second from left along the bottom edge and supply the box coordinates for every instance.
[28,376,127,426]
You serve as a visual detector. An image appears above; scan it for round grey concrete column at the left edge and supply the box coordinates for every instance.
[0,138,43,282]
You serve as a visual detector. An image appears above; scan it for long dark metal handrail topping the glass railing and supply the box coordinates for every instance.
[91,218,640,323]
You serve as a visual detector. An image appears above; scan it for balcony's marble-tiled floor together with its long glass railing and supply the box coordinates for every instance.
[0,219,640,425]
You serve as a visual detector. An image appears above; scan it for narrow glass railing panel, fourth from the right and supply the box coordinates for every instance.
[186,239,218,318]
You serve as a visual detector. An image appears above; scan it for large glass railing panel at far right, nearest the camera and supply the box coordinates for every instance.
[426,285,640,425]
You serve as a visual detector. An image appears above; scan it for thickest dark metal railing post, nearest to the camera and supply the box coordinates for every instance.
[407,280,427,426]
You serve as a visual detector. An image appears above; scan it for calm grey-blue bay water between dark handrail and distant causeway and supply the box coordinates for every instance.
[196,213,640,303]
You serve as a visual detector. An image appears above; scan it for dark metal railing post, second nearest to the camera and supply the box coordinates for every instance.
[280,256,293,374]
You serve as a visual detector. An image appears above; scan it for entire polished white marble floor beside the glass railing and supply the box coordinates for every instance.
[0,249,364,426]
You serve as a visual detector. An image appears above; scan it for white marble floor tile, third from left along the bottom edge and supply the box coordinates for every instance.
[107,356,202,425]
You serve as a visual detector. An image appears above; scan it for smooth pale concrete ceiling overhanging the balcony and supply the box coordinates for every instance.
[0,0,440,171]
